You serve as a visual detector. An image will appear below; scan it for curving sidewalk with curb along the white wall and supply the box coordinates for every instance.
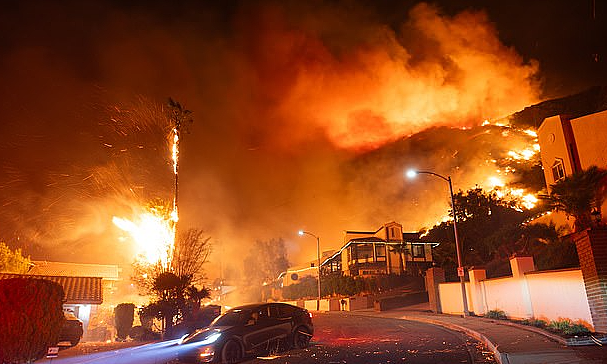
[352,304,607,364]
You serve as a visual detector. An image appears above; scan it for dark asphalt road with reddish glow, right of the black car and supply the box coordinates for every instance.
[240,312,495,364]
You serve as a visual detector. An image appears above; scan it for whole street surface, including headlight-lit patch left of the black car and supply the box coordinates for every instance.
[39,312,495,364]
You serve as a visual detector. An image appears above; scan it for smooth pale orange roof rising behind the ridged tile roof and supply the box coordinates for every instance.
[28,260,120,280]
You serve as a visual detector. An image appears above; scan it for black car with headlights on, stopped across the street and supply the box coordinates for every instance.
[178,303,314,363]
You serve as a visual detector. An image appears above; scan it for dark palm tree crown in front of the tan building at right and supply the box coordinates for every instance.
[550,166,607,231]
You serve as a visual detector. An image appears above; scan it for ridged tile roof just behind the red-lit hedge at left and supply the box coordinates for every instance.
[0,273,103,305]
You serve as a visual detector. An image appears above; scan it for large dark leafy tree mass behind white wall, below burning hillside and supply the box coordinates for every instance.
[425,188,577,278]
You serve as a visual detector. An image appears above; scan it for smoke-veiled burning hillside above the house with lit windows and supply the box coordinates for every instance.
[344,123,545,230]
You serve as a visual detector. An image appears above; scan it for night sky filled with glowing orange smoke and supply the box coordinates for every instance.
[0,0,607,272]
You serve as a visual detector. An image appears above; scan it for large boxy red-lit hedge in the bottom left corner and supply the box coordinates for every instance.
[0,278,64,364]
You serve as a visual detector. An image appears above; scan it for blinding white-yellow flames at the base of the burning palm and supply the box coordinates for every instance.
[112,212,175,267]
